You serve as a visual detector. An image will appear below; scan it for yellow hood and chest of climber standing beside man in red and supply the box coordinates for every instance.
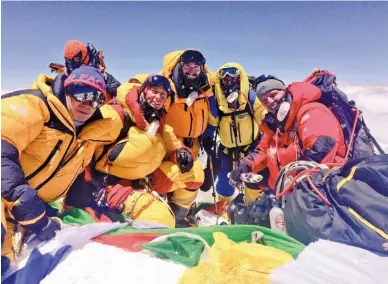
[209,62,261,148]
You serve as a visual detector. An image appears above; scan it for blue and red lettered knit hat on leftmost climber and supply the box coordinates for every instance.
[64,66,106,95]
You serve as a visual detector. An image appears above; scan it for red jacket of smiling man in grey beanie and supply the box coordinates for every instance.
[251,82,346,188]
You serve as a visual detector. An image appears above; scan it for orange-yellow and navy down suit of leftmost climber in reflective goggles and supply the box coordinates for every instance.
[1,74,122,260]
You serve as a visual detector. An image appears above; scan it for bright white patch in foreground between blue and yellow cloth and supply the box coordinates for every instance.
[41,242,186,284]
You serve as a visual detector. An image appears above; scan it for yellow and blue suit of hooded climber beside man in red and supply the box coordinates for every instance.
[203,62,266,200]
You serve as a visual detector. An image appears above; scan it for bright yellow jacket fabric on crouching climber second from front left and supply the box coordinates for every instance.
[96,83,182,180]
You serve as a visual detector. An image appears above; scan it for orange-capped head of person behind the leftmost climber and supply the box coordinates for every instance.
[63,40,90,74]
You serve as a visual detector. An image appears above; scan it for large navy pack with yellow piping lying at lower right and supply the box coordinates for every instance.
[282,155,388,256]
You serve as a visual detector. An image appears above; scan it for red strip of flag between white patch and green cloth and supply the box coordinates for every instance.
[93,233,164,252]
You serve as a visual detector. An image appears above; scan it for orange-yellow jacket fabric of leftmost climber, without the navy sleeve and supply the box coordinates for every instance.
[1,74,122,205]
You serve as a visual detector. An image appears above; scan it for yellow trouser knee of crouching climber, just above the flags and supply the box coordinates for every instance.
[122,191,175,228]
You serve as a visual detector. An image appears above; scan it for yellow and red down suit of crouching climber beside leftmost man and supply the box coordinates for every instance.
[96,83,204,223]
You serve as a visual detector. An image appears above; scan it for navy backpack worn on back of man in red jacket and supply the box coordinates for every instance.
[304,70,384,159]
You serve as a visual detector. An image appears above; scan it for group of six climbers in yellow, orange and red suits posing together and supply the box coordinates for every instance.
[2,37,382,266]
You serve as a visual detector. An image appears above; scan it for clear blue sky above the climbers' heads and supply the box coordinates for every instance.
[1,2,388,90]
